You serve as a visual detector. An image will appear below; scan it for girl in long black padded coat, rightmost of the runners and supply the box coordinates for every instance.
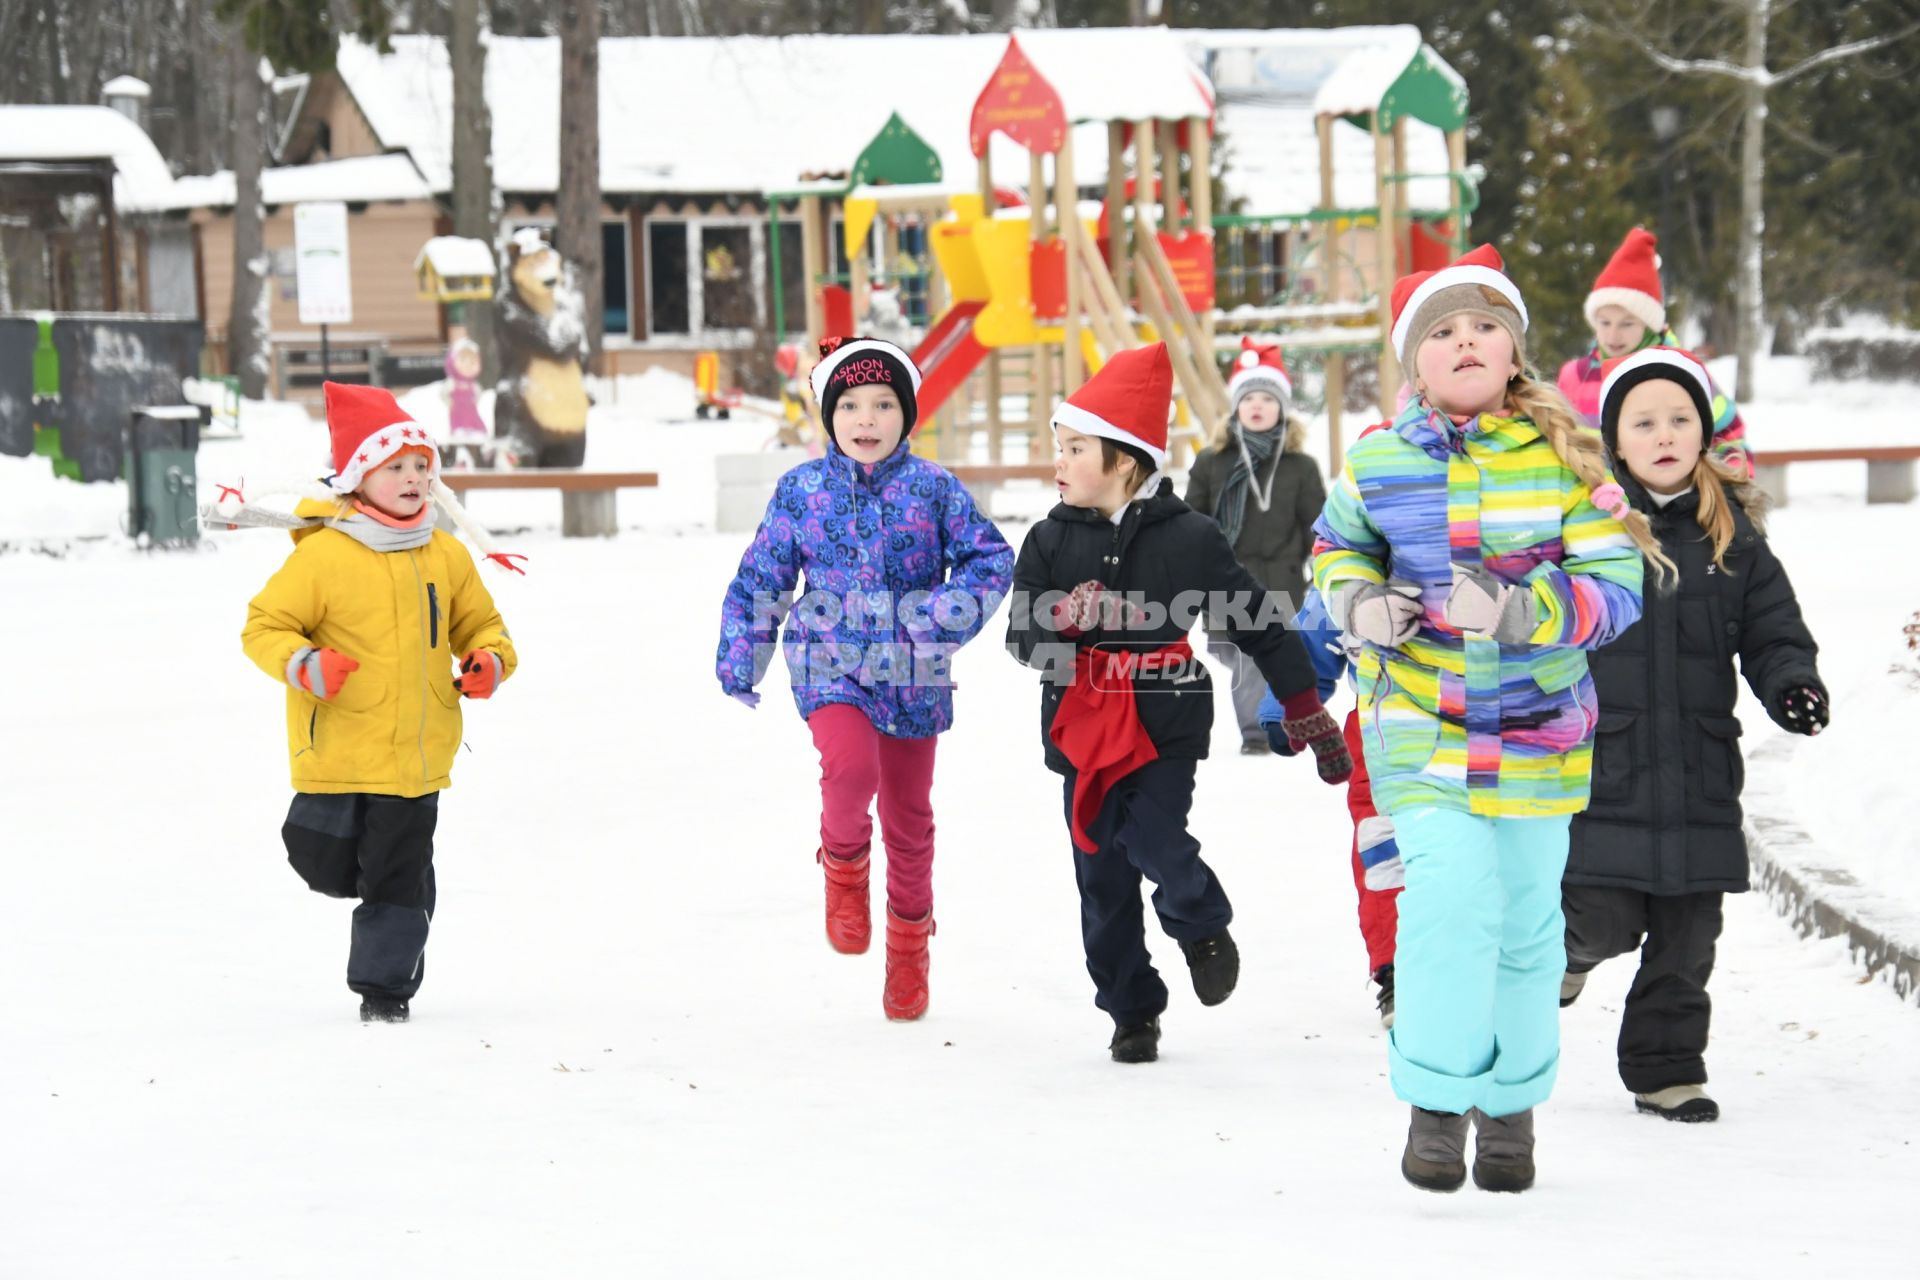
[1561,347,1828,1121]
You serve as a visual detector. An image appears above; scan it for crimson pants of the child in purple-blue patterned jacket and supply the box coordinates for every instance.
[806,702,939,919]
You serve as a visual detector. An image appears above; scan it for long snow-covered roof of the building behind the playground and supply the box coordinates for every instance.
[311,27,1448,213]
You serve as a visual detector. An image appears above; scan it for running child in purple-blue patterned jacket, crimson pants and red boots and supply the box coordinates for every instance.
[716,338,1014,1021]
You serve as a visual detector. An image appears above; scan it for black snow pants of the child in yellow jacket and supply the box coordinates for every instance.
[280,793,440,1000]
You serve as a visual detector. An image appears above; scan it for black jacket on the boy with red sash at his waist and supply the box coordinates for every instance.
[1006,487,1315,773]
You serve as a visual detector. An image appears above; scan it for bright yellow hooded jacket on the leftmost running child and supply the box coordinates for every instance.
[240,501,518,796]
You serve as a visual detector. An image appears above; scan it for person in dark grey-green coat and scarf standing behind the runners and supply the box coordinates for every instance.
[1187,338,1327,756]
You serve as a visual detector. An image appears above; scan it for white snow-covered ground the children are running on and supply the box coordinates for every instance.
[0,368,1920,1276]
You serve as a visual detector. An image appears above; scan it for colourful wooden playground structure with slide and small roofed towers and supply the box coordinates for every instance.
[748,27,1478,470]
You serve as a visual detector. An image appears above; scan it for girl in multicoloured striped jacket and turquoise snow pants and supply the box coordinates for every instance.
[1313,248,1665,1192]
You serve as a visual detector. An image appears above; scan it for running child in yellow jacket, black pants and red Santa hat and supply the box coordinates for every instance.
[240,382,518,1023]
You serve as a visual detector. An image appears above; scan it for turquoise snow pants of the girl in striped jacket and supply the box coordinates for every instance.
[1386,806,1572,1115]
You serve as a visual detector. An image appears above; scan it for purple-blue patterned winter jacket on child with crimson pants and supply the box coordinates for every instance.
[714,439,1014,737]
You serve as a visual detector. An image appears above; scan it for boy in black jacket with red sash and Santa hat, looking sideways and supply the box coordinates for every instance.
[1006,344,1352,1063]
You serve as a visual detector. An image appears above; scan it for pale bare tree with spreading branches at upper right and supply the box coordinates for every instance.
[1619,0,1920,399]
